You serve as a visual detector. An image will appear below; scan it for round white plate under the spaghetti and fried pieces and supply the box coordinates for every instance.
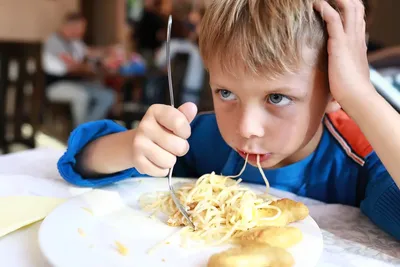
[39,178,323,267]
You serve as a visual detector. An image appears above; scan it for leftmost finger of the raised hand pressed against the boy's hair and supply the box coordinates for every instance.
[314,0,344,39]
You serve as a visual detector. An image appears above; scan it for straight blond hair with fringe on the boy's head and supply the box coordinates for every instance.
[199,0,337,77]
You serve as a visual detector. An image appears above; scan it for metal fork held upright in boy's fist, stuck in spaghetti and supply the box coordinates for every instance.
[166,15,196,230]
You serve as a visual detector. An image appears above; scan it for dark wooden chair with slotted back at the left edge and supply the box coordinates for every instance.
[0,41,44,153]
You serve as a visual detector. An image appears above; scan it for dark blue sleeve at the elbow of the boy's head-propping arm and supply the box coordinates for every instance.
[361,152,400,240]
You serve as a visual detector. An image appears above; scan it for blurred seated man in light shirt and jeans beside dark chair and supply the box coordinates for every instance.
[43,12,115,125]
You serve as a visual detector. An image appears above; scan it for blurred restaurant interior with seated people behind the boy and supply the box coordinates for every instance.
[0,0,400,153]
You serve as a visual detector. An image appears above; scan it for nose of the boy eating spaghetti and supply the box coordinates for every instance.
[239,108,264,139]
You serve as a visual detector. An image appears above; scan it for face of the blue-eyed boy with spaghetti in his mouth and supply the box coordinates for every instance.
[209,49,336,168]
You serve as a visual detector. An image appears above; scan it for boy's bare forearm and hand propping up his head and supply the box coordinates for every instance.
[314,0,400,186]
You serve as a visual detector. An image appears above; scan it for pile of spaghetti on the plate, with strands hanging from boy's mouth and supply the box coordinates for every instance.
[140,157,281,245]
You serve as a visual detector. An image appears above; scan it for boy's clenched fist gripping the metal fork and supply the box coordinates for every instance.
[132,103,197,177]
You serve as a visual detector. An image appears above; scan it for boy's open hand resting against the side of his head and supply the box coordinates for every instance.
[314,0,374,108]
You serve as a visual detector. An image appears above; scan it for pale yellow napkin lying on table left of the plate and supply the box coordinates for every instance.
[0,196,65,237]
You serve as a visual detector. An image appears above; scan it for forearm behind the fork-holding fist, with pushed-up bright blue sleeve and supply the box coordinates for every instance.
[58,120,140,187]
